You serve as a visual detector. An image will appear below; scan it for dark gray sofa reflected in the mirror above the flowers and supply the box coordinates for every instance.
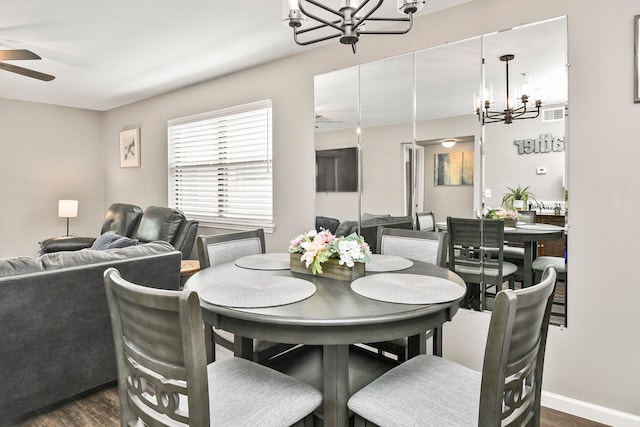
[316,213,413,254]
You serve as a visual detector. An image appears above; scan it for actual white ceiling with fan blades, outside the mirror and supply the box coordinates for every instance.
[0,0,471,111]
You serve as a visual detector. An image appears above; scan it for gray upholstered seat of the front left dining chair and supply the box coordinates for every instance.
[207,357,322,427]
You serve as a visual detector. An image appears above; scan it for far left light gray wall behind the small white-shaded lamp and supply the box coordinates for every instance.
[0,99,103,258]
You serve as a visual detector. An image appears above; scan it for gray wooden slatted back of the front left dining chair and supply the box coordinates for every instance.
[104,268,209,426]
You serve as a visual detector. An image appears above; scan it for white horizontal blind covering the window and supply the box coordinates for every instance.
[168,100,274,231]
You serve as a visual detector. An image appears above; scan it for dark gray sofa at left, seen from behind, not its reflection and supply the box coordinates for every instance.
[0,242,182,426]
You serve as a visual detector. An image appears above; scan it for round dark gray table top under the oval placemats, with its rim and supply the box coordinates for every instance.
[185,261,466,344]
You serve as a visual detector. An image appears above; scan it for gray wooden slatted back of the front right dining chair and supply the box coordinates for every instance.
[479,267,557,426]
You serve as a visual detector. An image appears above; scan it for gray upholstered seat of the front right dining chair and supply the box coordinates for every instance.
[349,355,482,427]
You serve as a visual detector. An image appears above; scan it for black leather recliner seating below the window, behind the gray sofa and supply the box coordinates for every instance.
[40,203,199,259]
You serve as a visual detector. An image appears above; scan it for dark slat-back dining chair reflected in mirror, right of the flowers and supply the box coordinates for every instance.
[447,217,518,310]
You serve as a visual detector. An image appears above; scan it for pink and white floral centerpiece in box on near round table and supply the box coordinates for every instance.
[289,230,371,275]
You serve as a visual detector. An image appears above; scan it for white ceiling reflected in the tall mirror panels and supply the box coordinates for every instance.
[315,18,568,131]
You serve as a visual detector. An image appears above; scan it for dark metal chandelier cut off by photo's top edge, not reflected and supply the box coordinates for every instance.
[283,0,426,53]
